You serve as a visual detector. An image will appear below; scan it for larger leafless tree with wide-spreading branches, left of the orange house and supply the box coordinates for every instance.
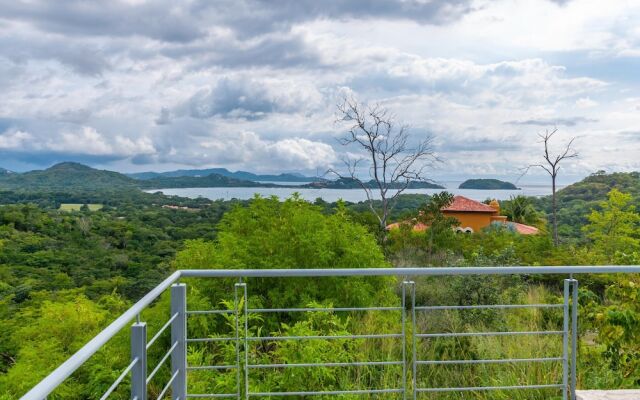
[329,97,438,232]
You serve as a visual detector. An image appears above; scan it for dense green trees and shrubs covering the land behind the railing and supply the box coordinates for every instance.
[0,170,640,400]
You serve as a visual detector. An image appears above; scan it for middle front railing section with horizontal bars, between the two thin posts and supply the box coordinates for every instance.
[240,280,407,399]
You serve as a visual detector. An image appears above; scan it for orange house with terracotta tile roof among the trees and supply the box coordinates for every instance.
[387,196,539,235]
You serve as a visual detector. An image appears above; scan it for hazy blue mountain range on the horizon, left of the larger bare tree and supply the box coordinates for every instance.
[126,168,323,182]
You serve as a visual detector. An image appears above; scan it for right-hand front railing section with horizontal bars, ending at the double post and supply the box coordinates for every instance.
[411,279,577,399]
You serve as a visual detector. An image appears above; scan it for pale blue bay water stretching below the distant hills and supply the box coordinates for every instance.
[149,182,551,203]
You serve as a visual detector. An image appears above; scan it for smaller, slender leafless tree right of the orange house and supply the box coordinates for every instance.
[522,128,578,246]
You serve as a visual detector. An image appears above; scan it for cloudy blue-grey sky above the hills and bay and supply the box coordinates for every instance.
[0,0,640,183]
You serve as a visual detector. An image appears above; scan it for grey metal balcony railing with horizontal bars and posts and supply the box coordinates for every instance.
[22,266,640,400]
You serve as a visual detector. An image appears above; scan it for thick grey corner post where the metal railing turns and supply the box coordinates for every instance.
[171,283,187,400]
